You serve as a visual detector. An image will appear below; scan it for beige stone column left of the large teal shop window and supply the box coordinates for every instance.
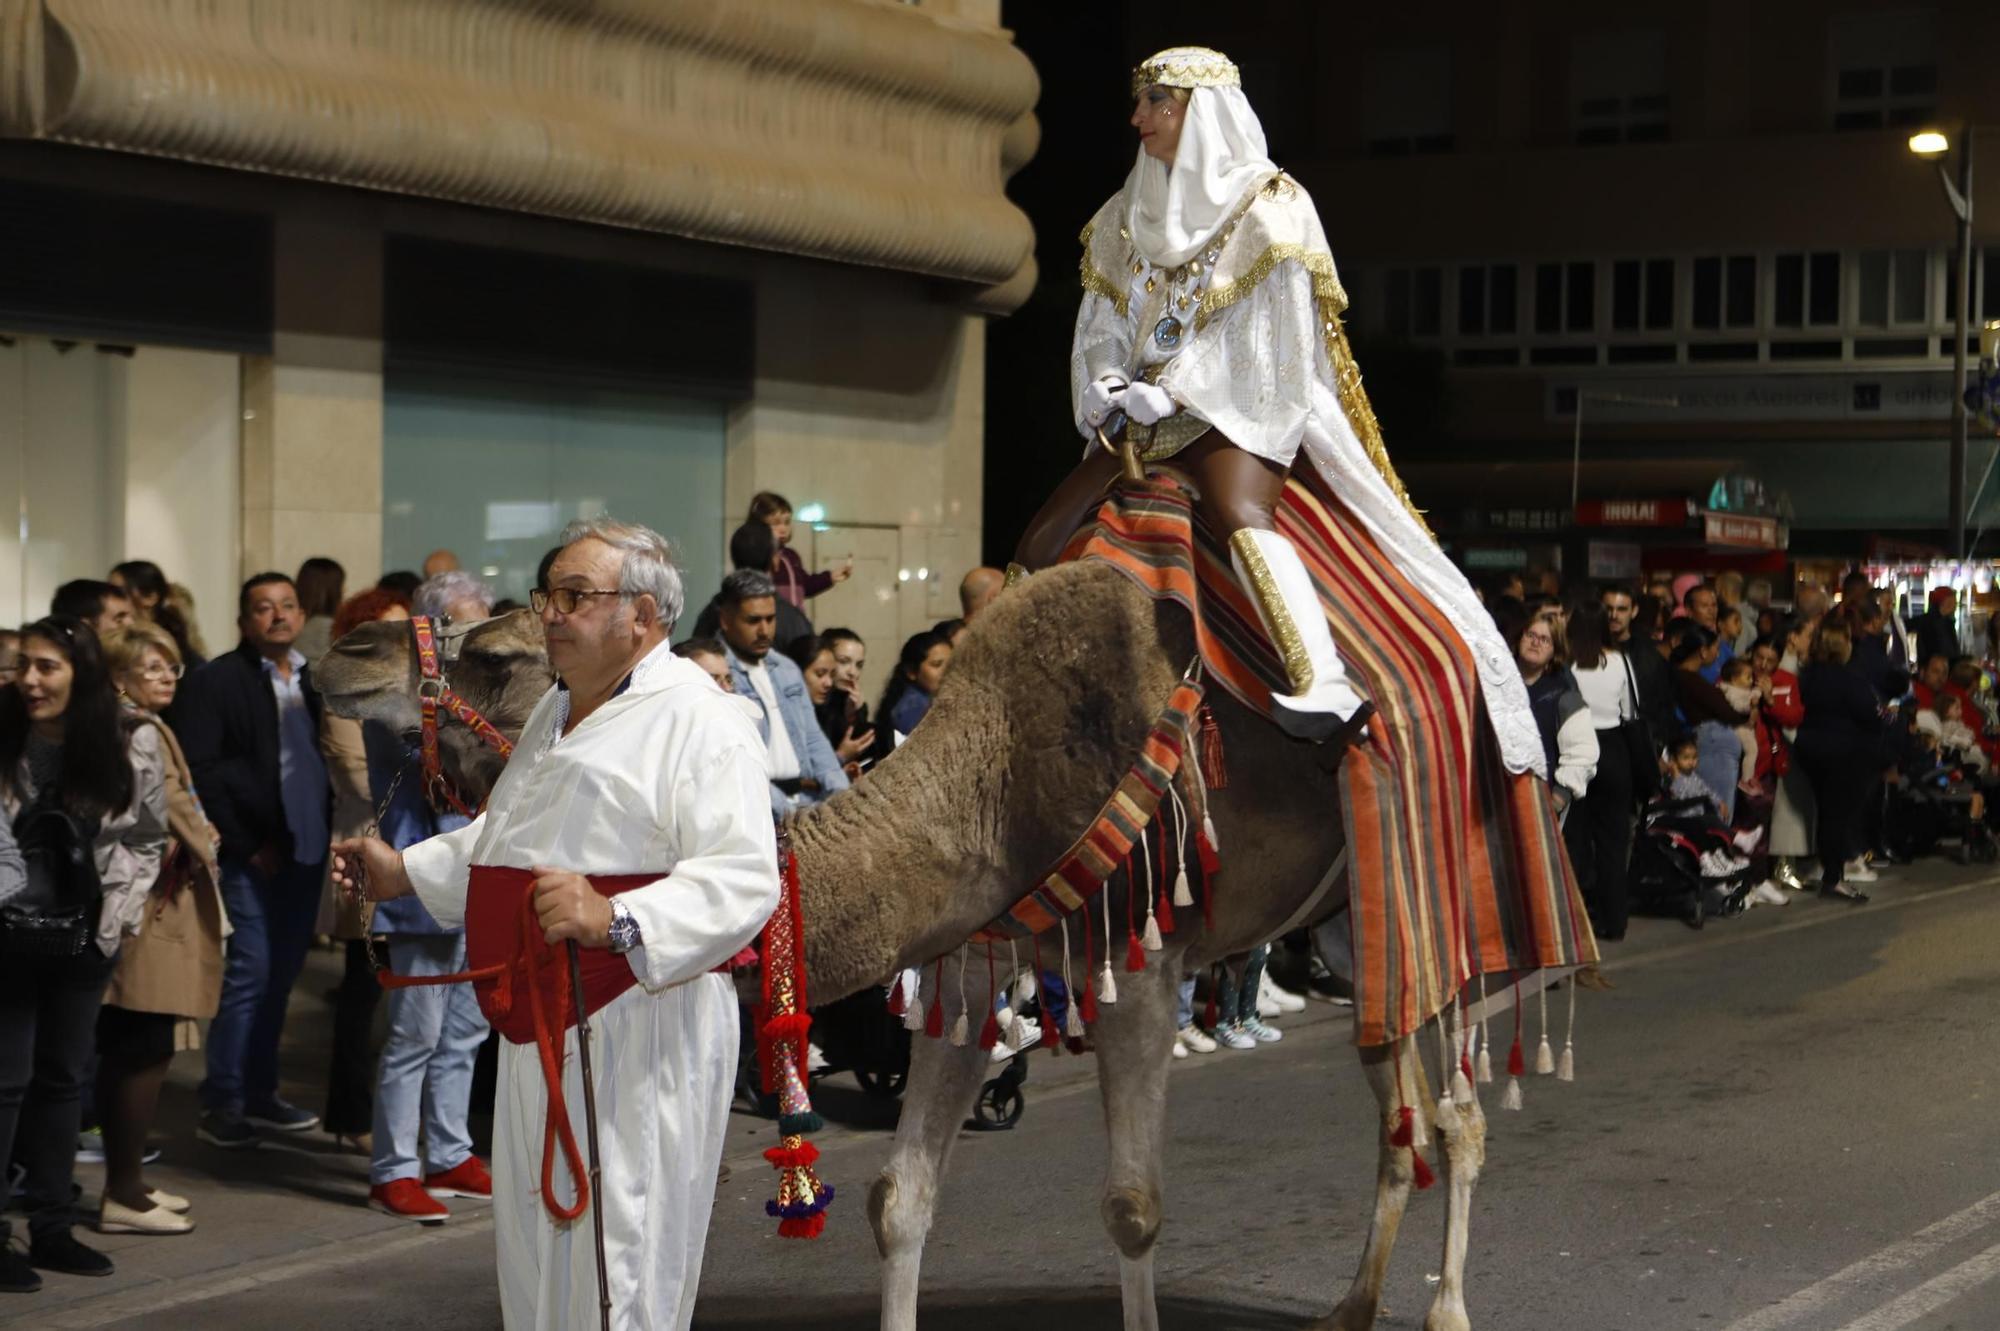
[242,216,382,590]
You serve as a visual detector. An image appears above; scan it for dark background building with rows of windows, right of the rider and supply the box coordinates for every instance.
[1146,0,2000,571]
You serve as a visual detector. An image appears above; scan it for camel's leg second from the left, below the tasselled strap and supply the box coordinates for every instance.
[1090,953,1180,1331]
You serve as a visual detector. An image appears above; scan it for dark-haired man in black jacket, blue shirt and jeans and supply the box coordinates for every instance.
[168,574,330,1147]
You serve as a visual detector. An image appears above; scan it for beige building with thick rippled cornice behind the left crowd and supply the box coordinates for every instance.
[0,0,1038,650]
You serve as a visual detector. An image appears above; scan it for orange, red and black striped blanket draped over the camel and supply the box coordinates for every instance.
[1064,470,1596,1045]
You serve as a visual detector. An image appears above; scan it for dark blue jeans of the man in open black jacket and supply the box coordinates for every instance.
[202,859,326,1113]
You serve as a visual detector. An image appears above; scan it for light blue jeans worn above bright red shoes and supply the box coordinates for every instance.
[368,933,486,1183]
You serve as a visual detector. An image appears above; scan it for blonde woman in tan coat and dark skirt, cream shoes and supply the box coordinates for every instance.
[98,622,228,1233]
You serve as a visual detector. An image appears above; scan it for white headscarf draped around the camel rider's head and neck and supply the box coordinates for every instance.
[1126,88,1278,268]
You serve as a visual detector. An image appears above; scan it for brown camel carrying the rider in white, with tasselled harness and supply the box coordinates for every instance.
[314,562,1486,1331]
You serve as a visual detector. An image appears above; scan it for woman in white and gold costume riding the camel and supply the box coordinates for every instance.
[1008,46,1546,771]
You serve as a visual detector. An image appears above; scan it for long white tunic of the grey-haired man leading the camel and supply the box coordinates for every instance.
[404,644,778,1331]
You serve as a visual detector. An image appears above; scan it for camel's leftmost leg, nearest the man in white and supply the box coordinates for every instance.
[868,965,996,1331]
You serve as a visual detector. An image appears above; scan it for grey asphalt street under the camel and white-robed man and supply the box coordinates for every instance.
[11,861,2000,1331]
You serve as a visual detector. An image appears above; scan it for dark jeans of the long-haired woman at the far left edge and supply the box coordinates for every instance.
[0,941,116,1241]
